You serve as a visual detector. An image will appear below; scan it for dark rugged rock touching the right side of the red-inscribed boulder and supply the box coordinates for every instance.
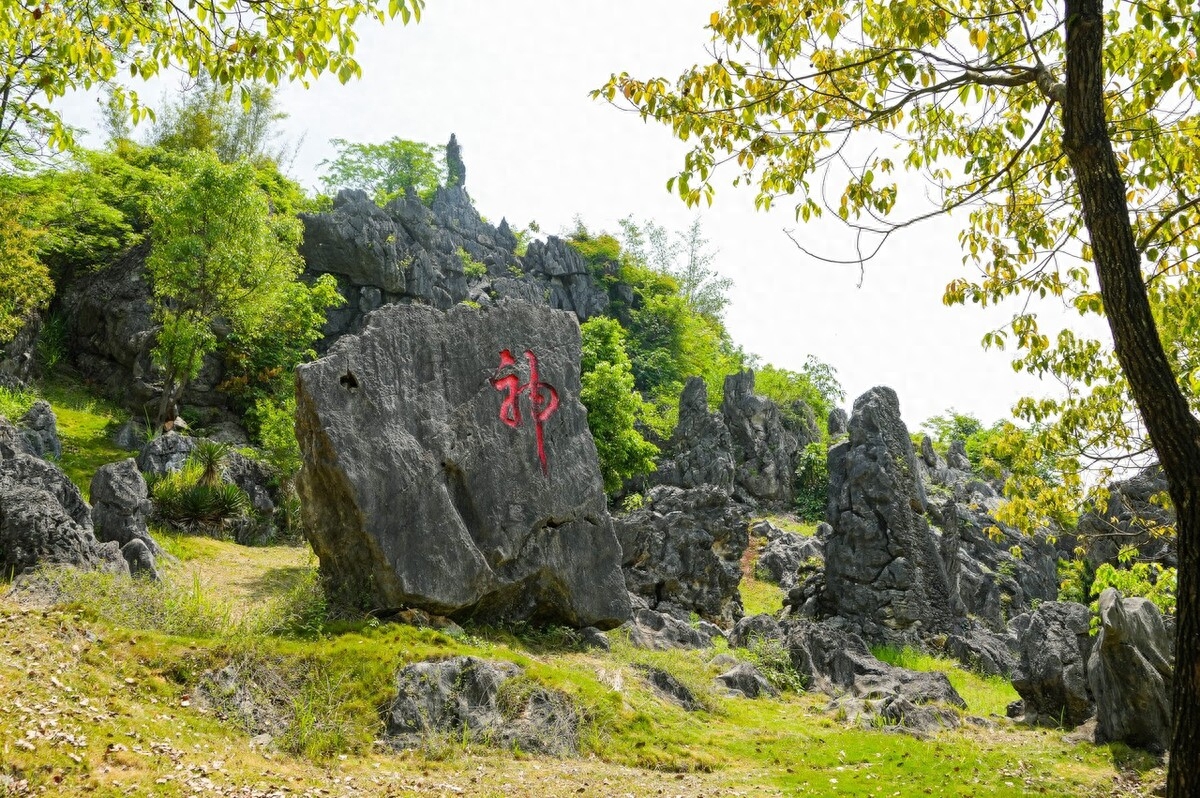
[616,485,749,626]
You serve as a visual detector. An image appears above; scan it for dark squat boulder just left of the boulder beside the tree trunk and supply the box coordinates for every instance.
[1013,601,1094,727]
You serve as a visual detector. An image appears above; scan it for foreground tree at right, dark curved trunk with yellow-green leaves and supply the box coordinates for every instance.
[596,0,1200,798]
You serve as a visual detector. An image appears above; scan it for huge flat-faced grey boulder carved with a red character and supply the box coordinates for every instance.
[296,302,630,629]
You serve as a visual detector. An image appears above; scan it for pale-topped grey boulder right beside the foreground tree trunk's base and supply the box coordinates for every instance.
[1087,588,1175,752]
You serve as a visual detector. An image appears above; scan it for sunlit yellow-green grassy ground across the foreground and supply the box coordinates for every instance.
[0,379,1162,798]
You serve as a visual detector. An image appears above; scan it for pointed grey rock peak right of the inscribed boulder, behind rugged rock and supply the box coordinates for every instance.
[654,377,736,493]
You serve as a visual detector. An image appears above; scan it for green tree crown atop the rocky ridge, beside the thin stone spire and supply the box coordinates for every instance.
[320,136,446,205]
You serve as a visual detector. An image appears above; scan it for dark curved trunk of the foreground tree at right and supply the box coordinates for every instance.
[1062,0,1200,798]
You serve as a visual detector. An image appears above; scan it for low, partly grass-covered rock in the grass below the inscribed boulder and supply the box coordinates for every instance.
[386,656,578,754]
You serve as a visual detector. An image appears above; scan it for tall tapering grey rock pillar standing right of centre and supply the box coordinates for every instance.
[821,388,956,643]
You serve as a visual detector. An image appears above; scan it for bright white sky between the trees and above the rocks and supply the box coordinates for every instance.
[60,0,1099,428]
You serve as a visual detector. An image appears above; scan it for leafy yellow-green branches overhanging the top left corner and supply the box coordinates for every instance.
[0,0,424,167]
